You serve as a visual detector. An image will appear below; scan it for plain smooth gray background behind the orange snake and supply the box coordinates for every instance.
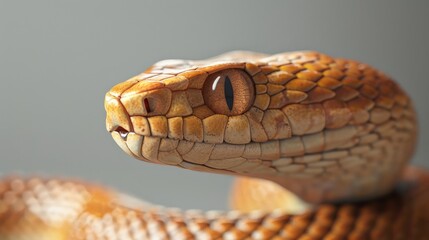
[0,0,429,209]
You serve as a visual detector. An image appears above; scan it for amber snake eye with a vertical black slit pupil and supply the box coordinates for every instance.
[203,69,255,116]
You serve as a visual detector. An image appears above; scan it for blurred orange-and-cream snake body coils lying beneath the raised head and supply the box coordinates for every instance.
[0,168,429,240]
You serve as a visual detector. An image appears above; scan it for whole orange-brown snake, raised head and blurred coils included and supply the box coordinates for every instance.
[0,51,429,240]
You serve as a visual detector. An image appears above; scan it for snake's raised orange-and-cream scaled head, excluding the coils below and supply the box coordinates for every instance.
[105,52,415,201]
